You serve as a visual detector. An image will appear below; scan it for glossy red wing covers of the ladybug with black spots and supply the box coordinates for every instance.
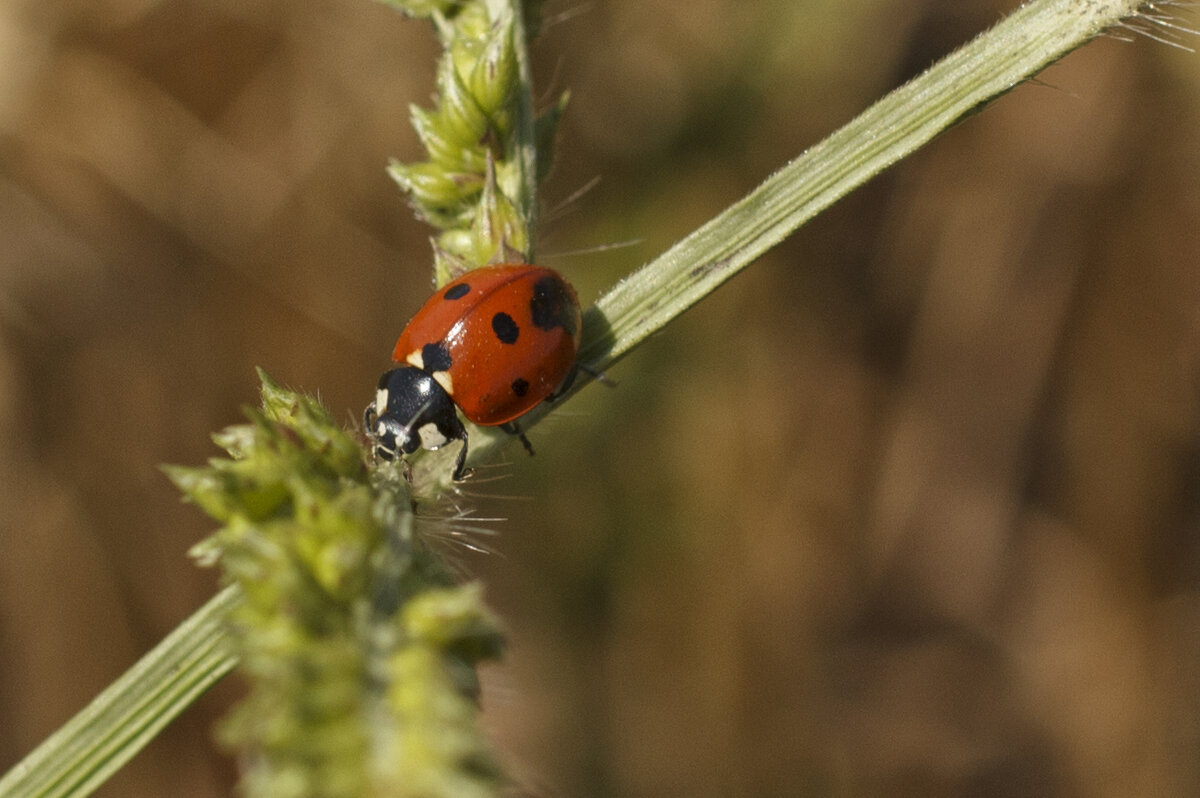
[392,264,581,426]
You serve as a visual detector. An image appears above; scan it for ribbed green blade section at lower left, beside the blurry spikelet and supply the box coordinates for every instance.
[0,588,239,798]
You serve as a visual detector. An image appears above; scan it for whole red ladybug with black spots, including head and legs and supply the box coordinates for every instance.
[364,264,581,481]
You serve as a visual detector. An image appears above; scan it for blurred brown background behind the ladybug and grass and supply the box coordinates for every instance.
[0,0,1200,798]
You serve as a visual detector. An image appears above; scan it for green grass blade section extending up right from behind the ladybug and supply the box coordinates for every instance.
[580,0,1144,371]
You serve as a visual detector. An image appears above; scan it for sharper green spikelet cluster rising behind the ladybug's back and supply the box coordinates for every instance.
[376,0,562,276]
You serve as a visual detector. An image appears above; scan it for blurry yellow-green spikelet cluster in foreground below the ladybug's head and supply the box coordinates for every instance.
[168,374,503,798]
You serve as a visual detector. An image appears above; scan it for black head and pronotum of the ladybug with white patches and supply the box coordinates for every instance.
[362,366,467,470]
